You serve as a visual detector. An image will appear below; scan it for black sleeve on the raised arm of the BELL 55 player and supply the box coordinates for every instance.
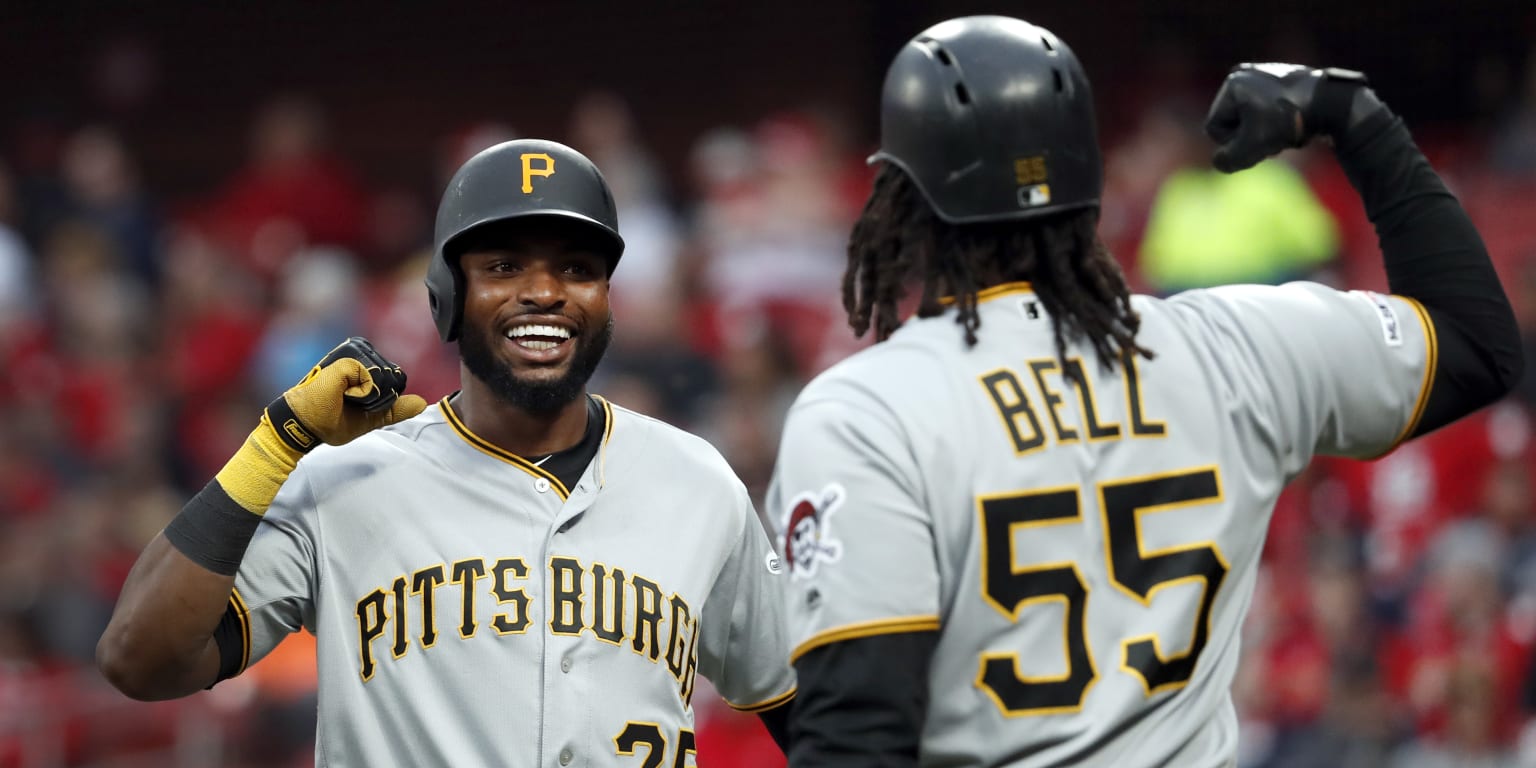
[1336,108,1524,436]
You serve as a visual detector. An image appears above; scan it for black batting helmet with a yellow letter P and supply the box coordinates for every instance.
[427,138,624,341]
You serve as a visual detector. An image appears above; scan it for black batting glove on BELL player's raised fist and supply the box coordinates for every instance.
[1206,65,1385,174]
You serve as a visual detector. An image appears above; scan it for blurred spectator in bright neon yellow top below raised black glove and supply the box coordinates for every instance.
[1140,104,1338,293]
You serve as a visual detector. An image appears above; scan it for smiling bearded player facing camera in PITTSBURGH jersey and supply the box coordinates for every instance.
[98,140,794,768]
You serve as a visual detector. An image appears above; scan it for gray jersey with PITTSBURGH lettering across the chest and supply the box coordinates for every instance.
[232,401,794,768]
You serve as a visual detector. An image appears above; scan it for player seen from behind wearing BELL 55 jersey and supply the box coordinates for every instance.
[768,17,1521,768]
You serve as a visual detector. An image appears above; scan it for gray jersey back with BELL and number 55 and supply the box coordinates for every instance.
[768,283,1435,768]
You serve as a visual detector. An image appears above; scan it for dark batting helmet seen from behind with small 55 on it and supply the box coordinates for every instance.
[869,15,1104,224]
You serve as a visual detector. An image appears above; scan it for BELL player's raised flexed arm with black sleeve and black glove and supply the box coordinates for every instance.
[1206,65,1524,436]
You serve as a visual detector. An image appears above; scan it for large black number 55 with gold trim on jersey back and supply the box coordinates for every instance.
[975,467,1229,716]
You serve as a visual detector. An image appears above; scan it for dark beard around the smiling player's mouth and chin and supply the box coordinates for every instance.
[459,313,613,415]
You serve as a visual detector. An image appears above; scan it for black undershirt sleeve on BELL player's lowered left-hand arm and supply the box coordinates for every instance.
[788,631,938,768]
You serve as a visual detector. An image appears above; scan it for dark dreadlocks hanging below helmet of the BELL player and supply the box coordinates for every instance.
[843,163,1152,375]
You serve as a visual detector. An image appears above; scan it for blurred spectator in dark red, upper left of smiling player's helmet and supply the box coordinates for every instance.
[212,97,367,275]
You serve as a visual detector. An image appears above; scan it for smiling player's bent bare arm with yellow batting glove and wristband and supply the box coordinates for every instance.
[97,336,425,700]
